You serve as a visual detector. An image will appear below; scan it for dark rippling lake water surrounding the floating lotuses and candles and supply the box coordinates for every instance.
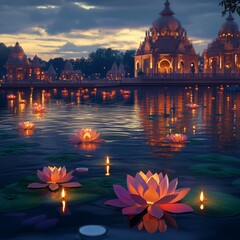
[0,86,240,240]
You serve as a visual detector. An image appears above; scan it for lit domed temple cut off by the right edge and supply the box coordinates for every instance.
[203,13,240,74]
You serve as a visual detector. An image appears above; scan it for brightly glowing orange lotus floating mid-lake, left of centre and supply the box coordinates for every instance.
[69,128,104,144]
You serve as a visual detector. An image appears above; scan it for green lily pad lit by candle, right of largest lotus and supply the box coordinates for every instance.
[183,189,240,217]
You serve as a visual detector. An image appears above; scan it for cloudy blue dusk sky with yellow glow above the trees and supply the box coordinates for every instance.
[0,0,239,60]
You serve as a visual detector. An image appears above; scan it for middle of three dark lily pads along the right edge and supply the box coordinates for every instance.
[190,163,240,177]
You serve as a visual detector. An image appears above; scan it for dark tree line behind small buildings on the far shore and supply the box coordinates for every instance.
[0,43,135,78]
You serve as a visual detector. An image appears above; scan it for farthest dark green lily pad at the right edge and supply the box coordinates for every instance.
[191,154,240,163]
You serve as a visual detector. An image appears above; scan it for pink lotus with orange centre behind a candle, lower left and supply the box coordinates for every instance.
[28,166,81,191]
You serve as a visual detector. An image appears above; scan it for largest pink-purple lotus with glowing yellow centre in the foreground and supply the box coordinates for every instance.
[105,171,193,219]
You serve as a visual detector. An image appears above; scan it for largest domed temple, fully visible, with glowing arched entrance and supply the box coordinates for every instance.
[134,0,199,77]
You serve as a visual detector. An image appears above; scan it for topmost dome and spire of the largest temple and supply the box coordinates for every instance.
[152,0,183,35]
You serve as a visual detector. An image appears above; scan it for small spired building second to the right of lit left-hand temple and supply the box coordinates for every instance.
[60,60,83,82]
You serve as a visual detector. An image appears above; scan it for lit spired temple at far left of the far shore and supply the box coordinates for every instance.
[6,42,44,82]
